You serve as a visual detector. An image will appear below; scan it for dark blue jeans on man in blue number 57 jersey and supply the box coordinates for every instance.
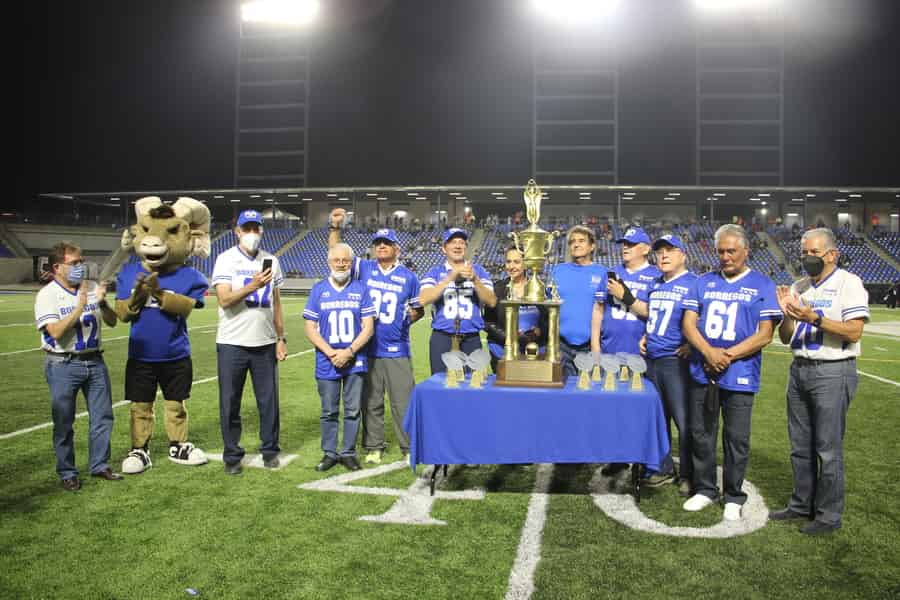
[647,356,693,481]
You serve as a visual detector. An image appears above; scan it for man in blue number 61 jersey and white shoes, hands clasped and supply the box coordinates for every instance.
[682,225,782,521]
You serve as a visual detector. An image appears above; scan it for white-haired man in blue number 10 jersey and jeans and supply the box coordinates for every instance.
[303,243,375,471]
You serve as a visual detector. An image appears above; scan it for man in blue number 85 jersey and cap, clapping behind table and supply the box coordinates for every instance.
[419,227,497,375]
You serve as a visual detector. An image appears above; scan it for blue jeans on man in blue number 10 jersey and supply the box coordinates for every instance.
[316,373,363,457]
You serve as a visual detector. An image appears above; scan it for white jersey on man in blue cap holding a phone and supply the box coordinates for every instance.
[212,246,284,347]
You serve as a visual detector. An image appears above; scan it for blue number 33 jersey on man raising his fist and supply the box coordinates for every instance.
[353,258,420,358]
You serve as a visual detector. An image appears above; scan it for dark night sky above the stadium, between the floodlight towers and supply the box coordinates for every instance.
[17,0,900,199]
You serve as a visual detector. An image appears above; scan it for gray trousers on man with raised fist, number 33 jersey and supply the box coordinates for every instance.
[362,358,415,452]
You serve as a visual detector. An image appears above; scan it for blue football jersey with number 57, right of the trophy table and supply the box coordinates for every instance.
[646,271,697,358]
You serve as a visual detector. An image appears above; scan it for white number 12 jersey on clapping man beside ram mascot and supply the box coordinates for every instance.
[34,279,103,354]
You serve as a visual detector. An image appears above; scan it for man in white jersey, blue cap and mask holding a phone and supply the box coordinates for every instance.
[212,210,287,475]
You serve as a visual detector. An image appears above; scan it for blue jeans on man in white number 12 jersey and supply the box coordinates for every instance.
[44,354,113,479]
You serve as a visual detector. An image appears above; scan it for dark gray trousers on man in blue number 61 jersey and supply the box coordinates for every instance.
[688,380,753,504]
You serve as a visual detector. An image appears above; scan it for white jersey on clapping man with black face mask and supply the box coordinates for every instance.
[791,269,869,360]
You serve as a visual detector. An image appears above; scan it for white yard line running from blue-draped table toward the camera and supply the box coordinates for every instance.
[506,463,553,600]
